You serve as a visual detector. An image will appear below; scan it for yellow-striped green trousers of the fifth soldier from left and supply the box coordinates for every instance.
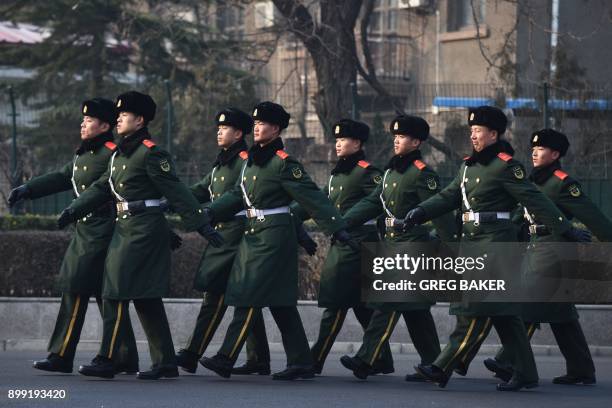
[310,305,393,368]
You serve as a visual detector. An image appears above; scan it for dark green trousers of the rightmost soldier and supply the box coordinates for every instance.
[495,320,595,377]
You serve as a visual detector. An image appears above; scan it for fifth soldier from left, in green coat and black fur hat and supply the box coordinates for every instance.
[286,119,393,374]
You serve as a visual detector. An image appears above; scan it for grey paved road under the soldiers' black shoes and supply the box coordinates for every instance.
[0,352,612,408]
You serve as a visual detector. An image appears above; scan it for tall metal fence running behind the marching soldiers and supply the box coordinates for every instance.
[0,81,612,216]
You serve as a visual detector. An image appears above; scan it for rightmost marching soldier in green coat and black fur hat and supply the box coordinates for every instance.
[476,129,612,385]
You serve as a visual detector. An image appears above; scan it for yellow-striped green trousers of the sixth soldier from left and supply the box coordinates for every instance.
[357,309,440,366]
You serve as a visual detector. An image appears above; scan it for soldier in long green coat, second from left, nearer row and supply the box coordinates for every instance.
[58,91,222,380]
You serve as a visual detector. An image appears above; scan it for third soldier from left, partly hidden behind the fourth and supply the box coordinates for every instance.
[176,108,270,375]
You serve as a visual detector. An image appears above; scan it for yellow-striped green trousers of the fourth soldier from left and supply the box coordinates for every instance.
[219,306,313,366]
